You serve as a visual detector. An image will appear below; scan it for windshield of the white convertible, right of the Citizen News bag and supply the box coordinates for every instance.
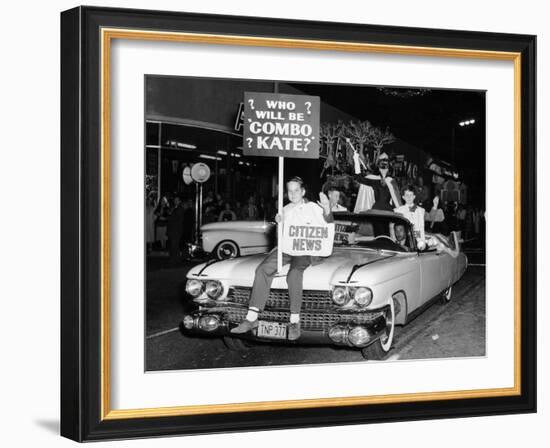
[334,215,415,252]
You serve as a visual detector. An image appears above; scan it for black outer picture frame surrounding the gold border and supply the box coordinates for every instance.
[61,7,537,441]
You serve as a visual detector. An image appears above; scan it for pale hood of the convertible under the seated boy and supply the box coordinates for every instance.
[188,249,396,290]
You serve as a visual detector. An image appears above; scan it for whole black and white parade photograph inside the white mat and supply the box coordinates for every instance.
[143,74,486,371]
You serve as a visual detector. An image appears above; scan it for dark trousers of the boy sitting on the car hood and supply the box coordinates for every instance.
[249,248,311,314]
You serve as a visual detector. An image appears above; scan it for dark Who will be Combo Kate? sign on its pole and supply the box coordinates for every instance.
[243,92,321,272]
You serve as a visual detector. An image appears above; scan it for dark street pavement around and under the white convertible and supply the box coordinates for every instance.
[146,253,486,371]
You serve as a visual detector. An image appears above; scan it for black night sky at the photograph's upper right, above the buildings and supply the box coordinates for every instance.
[292,83,485,183]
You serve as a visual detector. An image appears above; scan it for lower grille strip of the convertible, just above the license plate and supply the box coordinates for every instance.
[220,307,383,331]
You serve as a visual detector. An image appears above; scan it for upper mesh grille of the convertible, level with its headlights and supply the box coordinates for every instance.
[227,286,335,310]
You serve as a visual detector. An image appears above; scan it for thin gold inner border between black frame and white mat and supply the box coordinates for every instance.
[100,28,521,420]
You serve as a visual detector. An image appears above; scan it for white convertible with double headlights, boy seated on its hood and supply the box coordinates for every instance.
[181,211,468,359]
